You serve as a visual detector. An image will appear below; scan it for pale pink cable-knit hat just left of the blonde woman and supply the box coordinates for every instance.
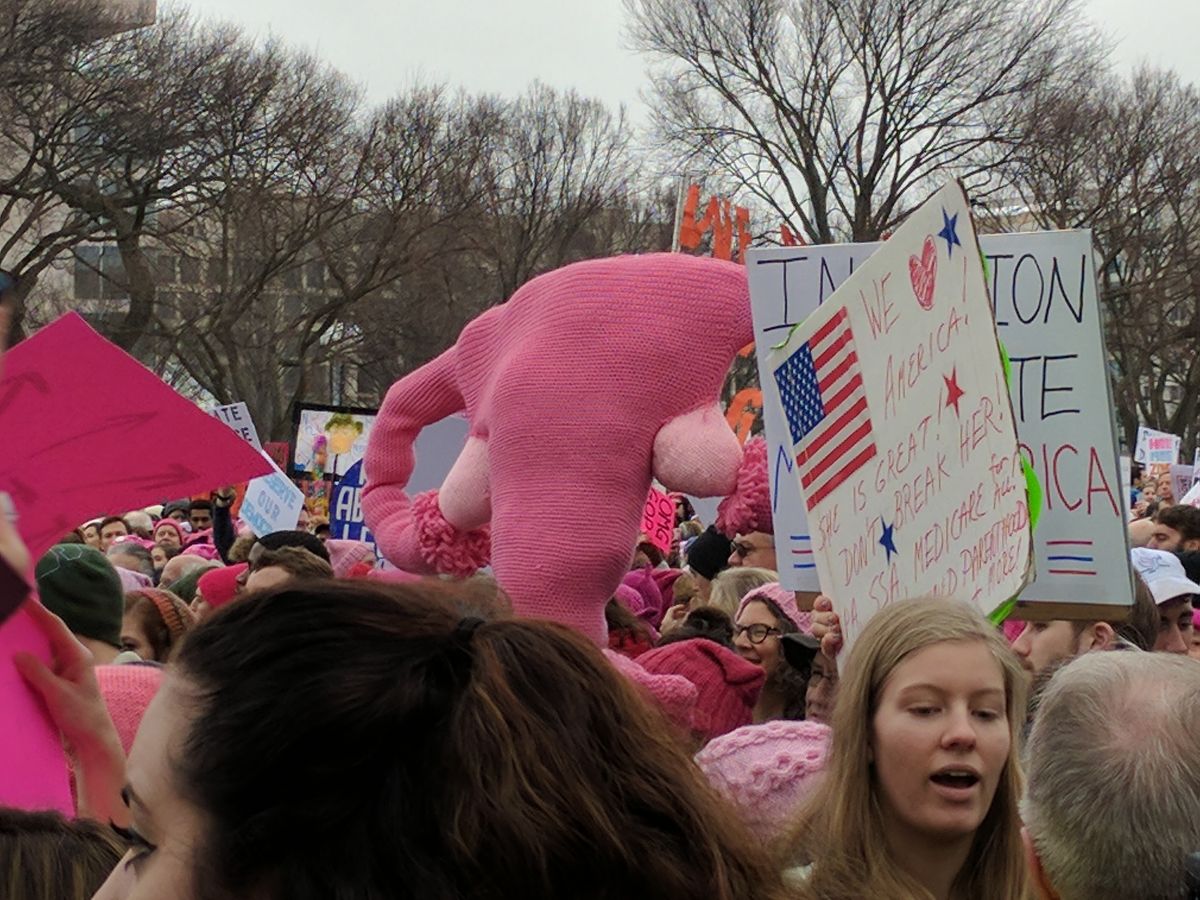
[696,720,830,842]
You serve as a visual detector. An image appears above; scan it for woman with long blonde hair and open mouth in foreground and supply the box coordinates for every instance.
[788,600,1027,900]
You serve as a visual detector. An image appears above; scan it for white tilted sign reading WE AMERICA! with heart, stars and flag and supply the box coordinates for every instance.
[769,184,1033,649]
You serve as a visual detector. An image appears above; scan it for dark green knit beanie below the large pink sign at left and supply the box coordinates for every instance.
[35,544,125,648]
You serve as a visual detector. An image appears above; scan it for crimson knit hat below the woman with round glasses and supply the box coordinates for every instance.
[637,638,767,740]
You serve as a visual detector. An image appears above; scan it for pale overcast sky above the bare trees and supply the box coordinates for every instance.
[171,0,1200,112]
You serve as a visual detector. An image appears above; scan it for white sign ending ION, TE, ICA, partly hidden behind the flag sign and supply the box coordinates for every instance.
[748,232,1133,618]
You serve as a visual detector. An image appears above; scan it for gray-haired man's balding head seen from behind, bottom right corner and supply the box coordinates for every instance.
[1021,652,1200,900]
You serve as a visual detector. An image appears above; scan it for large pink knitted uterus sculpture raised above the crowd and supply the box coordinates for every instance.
[362,253,754,642]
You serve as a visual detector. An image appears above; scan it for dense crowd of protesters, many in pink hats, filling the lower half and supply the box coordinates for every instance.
[0,439,1200,900]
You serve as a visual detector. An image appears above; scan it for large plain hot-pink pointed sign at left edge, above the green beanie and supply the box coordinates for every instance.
[0,313,270,558]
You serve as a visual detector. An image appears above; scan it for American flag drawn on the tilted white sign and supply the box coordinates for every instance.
[775,308,875,509]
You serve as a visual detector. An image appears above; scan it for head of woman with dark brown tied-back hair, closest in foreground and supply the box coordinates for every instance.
[75,582,781,900]
